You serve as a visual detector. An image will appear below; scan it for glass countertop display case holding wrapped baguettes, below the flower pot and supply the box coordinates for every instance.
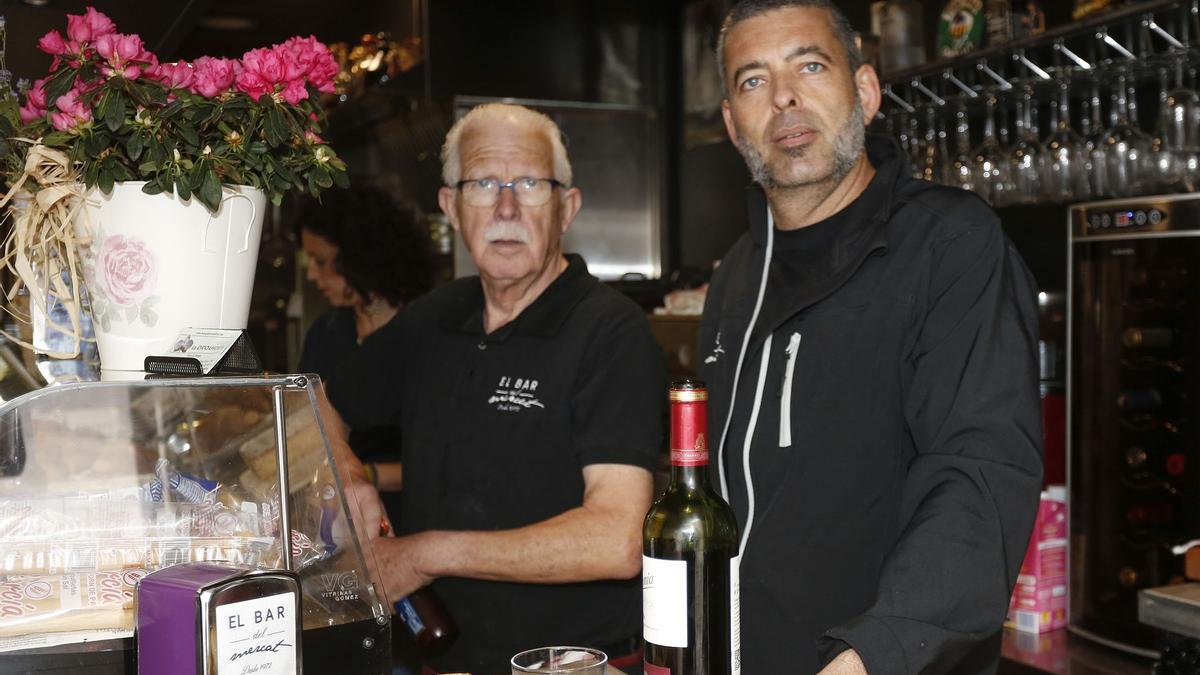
[0,376,391,673]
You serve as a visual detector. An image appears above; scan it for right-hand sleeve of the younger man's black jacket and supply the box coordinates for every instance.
[820,221,1042,675]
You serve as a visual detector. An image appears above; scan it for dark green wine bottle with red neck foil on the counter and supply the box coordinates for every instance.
[642,380,742,675]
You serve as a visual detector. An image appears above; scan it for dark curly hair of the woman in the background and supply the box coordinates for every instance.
[296,185,433,305]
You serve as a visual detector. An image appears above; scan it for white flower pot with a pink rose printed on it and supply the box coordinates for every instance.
[77,183,266,370]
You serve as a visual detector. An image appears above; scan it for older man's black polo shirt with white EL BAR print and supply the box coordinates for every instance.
[329,256,666,675]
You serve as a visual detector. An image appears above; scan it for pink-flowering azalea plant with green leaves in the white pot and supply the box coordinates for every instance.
[0,7,347,211]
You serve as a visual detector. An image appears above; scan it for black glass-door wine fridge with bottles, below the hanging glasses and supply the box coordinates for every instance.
[1067,195,1200,656]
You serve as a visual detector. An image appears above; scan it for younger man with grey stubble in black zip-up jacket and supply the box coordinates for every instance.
[701,0,1042,675]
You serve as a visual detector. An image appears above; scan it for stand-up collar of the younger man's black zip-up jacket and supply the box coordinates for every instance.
[746,135,910,258]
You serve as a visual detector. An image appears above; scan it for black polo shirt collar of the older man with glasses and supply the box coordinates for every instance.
[439,253,599,342]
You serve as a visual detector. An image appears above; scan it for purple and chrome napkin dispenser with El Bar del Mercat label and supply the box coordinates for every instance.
[136,562,302,675]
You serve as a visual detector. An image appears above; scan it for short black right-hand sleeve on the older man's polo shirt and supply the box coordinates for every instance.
[571,302,666,472]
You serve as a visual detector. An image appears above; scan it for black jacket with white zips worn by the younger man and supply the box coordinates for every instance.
[700,138,1042,675]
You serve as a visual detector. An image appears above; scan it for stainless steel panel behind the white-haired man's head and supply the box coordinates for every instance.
[454,96,662,280]
